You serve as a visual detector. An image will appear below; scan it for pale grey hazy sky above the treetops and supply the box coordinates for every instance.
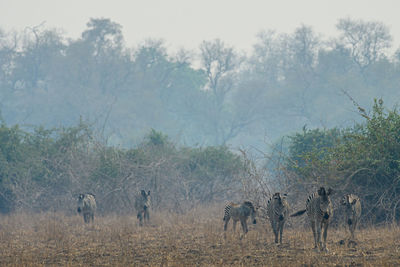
[0,0,400,51]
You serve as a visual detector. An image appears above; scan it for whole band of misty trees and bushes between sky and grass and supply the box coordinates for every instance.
[0,18,400,225]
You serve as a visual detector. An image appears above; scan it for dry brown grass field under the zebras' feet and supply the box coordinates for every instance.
[0,209,400,266]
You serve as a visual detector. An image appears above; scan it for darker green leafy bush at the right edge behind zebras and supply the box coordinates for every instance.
[288,99,400,222]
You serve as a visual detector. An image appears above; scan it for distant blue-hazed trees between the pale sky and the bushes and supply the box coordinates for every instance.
[0,18,400,149]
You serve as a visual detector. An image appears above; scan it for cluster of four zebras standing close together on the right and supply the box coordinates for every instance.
[223,187,361,251]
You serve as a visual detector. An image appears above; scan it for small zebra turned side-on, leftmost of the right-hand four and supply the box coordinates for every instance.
[223,201,257,234]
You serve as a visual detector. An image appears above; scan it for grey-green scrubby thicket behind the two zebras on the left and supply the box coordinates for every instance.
[0,123,244,216]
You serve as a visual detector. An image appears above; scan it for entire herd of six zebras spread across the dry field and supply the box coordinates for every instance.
[77,187,361,251]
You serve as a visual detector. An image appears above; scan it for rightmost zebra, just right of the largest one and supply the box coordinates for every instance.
[340,194,361,240]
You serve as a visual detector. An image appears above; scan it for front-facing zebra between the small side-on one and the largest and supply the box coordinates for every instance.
[267,193,289,244]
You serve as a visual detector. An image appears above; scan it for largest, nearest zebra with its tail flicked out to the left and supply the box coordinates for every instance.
[290,187,333,251]
